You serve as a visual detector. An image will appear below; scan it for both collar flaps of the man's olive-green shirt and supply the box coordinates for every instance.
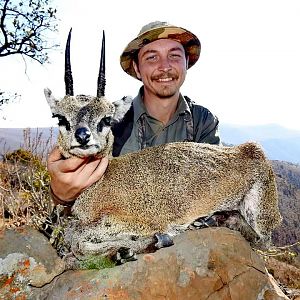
[133,86,191,122]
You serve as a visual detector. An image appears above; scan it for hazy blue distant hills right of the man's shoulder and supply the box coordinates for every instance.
[220,124,300,164]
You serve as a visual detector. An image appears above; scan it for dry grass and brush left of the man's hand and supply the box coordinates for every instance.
[0,129,53,229]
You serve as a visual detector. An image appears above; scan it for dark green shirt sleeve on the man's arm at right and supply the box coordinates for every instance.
[193,105,221,145]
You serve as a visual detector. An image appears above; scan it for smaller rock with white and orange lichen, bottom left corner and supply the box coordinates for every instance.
[0,227,65,299]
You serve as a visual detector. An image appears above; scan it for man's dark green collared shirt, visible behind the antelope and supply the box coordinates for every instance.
[120,88,220,155]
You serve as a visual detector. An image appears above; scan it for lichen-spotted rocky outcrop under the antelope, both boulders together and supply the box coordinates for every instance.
[0,228,287,300]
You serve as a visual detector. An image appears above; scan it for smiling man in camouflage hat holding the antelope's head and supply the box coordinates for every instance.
[48,21,220,206]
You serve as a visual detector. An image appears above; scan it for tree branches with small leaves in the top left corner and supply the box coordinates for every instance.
[0,0,57,64]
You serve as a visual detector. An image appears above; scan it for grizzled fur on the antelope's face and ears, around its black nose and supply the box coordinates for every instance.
[44,88,132,158]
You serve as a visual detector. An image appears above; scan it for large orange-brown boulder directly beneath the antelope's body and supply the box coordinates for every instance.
[24,228,288,300]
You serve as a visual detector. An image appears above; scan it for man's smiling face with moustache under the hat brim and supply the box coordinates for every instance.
[134,39,187,98]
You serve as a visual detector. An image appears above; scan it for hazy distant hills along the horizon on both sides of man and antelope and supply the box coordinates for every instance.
[0,124,300,164]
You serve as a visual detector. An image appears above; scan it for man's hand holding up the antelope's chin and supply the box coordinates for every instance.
[47,148,108,204]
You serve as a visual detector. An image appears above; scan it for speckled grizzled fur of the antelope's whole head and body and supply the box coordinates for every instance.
[45,90,281,256]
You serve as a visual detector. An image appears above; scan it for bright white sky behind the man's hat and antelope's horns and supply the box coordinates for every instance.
[0,0,300,130]
